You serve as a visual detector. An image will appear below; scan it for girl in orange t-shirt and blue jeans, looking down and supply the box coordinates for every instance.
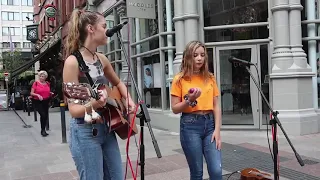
[171,41,222,180]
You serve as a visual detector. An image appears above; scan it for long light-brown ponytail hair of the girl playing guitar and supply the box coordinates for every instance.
[65,9,102,57]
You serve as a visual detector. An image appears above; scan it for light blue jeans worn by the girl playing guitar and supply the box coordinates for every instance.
[69,119,124,180]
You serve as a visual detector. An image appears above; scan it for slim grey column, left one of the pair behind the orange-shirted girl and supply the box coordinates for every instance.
[172,0,185,74]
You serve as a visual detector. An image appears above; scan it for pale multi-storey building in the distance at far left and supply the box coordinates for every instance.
[0,0,33,89]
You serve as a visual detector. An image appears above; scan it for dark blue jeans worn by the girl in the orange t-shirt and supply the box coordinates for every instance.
[180,113,222,180]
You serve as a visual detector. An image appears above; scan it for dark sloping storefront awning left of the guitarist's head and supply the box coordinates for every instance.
[10,40,61,78]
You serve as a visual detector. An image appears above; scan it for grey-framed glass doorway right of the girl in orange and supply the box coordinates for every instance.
[208,44,269,129]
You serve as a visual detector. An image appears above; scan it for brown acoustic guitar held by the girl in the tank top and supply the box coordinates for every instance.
[63,83,138,140]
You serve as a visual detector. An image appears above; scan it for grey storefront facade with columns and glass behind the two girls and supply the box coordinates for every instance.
[93,0,320,135]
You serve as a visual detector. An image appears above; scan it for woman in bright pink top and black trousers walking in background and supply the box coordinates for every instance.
[30,71,52,136]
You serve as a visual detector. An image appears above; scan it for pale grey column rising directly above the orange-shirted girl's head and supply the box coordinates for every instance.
[183,0,200,45]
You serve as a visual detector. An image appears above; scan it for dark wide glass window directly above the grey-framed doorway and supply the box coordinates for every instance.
[203,0,269,42]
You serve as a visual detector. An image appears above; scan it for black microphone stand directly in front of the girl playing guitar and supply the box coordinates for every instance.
[117,29,162,180]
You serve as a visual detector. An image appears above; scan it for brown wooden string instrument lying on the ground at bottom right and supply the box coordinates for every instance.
[241,168,272,180]
